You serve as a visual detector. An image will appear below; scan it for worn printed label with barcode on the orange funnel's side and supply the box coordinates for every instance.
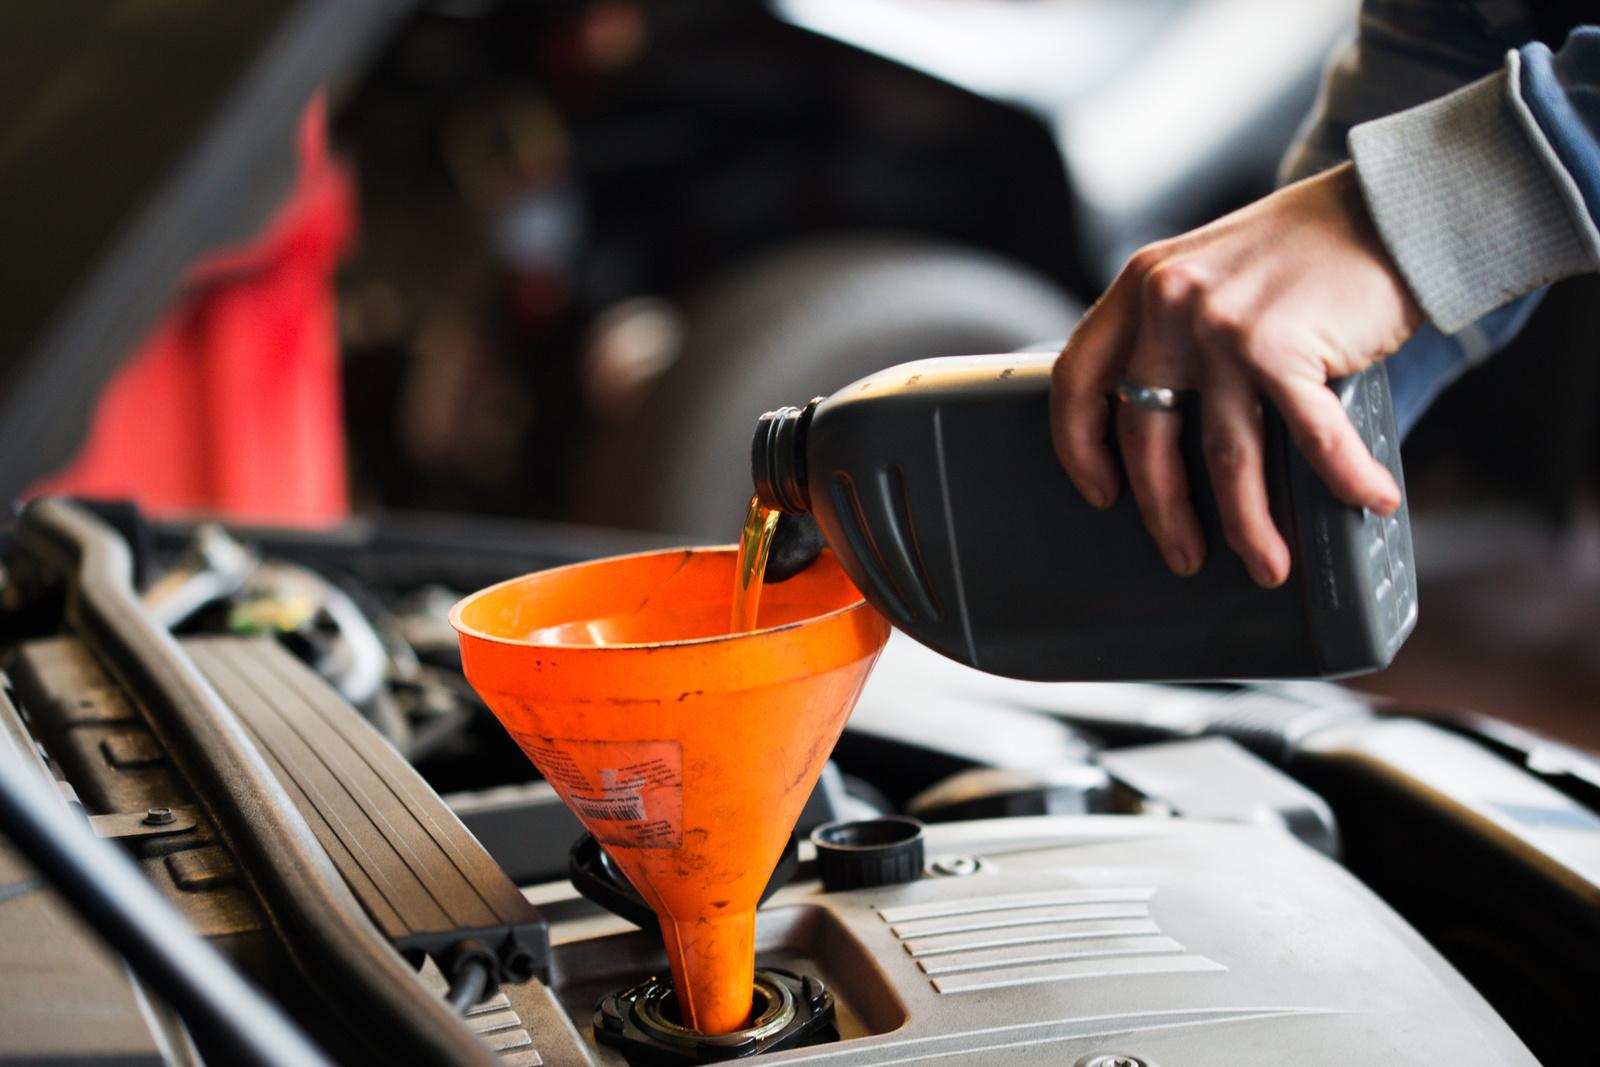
[517,734,683,848]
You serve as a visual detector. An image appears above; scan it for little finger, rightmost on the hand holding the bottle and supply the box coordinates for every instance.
[1264,379,1400,515]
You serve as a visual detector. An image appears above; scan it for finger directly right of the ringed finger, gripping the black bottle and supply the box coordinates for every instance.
[1200,362,1290,589]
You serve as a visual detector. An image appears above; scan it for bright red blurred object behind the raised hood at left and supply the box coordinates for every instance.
[29,96,355,525]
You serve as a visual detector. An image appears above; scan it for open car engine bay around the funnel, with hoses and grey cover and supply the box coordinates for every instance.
[0,501,1600,1067]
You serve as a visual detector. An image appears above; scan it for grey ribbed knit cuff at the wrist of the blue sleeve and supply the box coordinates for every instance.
[1350,53,1600,334]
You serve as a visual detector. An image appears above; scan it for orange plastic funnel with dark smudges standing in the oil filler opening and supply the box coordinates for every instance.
[450,547,890,1033]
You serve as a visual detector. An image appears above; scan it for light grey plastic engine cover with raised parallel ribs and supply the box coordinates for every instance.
[547,816,1534,1067]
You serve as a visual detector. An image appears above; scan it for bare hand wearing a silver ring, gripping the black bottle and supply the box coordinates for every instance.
[1050,163,1422,587]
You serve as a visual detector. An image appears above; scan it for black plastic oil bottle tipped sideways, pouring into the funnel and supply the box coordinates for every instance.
[752,354,1416,681]
